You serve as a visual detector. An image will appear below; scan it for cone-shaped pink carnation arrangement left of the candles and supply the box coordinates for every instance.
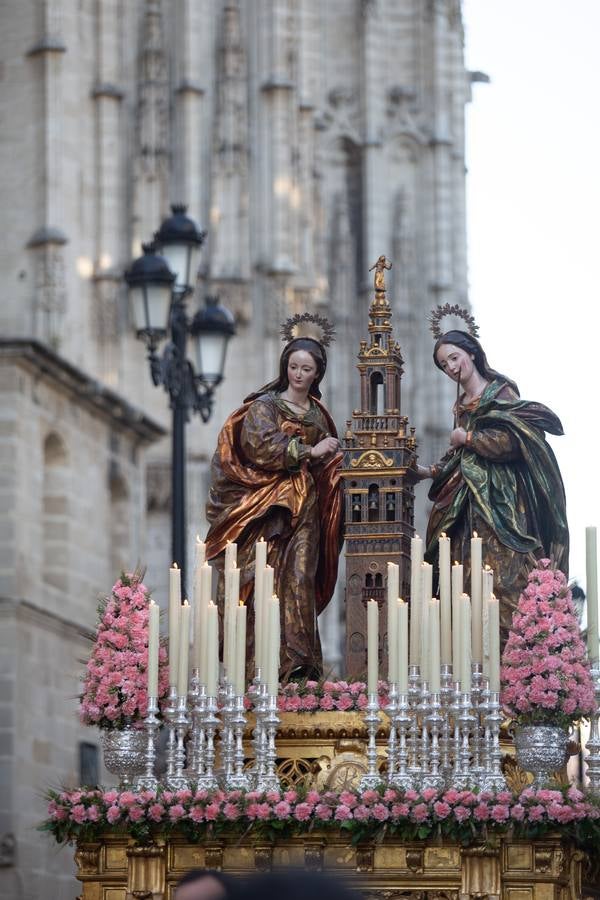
[79,572,169,728]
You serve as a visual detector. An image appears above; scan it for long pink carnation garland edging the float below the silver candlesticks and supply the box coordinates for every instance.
[40,785,600,846]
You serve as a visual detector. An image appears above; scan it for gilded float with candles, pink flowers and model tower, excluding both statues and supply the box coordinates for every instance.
[42,258,600,900]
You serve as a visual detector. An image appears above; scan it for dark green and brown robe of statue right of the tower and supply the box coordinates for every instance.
[426,380,569,642]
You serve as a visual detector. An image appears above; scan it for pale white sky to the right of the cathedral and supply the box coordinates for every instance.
[463,0,600,587]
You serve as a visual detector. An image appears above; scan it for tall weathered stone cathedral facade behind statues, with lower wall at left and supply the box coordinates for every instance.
[0,0,470,900]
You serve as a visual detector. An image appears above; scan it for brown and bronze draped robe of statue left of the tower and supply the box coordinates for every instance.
[206,392,342,679]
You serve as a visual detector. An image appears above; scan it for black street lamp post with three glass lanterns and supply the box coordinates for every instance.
[125,205,235,585]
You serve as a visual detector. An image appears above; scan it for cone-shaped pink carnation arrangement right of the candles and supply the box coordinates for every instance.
[501,559,596,728]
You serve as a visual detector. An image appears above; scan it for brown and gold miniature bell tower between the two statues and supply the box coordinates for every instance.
[341,256,418,678]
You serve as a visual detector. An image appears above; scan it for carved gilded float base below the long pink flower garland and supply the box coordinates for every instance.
[75,832,600,900]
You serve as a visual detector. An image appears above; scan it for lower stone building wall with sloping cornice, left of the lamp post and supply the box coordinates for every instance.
[0,340,162,900]
